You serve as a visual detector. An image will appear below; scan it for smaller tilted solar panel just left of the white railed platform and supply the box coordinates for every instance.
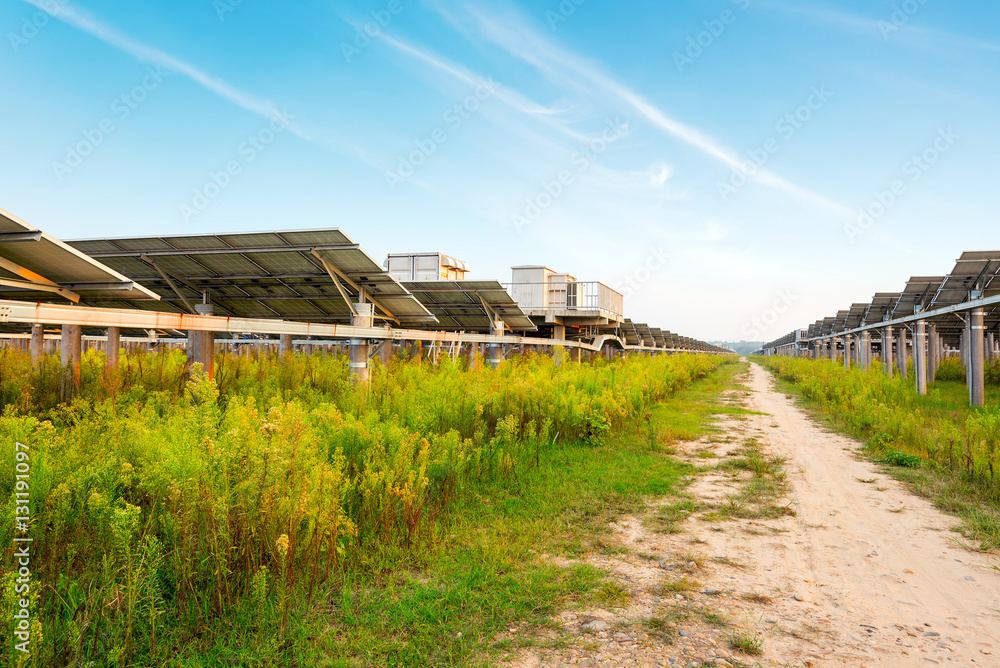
[402,281,537,332]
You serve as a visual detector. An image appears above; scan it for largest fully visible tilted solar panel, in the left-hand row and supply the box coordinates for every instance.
[67,228,436,325]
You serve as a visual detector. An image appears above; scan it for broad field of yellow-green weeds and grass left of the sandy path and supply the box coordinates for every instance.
[0,350,737,668]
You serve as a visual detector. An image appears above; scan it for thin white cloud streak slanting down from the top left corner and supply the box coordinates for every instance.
[23,0,363,158]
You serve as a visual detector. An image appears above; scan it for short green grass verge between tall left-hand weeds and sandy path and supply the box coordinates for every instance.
[316,365,740,666]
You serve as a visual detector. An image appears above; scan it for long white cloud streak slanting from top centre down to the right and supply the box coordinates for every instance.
[435,2,853,216]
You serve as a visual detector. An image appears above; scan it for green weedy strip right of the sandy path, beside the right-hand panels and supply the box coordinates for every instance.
[755,357,1000,550]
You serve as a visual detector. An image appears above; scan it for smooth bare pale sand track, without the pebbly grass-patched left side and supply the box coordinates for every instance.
[728,365,1000,666]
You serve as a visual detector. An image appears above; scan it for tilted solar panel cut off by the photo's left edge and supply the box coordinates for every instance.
[0,210,157,301]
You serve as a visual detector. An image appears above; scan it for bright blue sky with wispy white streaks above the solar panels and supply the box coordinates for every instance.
[0,0,1000,340]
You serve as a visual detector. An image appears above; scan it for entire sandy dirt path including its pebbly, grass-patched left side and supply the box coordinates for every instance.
[510,365,1000,668]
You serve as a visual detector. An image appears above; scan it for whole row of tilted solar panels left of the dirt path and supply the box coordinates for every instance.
[0,217,729,352]
